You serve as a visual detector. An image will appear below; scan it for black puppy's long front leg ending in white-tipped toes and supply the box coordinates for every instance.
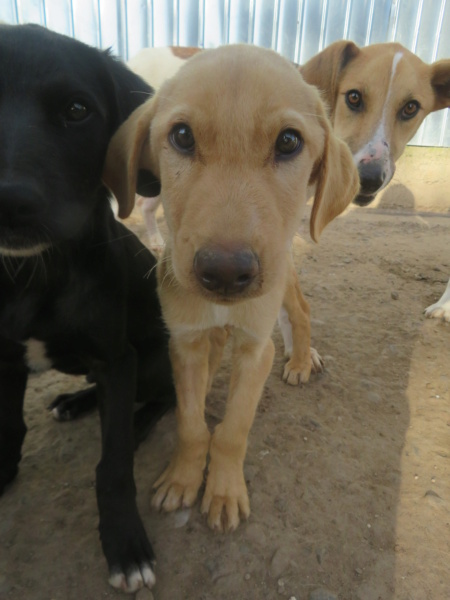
[93,346,155,592]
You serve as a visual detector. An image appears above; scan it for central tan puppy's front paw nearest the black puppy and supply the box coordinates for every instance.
[152,443,209,511]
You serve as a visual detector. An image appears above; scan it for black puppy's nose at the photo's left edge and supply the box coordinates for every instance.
[0,183,46,227]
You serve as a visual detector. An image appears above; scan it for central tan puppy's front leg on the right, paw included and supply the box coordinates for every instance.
[202,336,274,531]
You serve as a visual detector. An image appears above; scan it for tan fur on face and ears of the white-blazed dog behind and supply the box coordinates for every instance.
[299,41,450,163]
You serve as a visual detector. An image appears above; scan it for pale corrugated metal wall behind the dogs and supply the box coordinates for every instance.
[0,0,450,146]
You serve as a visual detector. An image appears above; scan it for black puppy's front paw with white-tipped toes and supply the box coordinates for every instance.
[99,512,155,593]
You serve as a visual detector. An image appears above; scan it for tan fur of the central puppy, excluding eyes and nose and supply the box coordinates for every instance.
[104,45,358,531]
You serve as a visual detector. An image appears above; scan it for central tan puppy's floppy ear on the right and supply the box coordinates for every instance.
[309,111,359,242]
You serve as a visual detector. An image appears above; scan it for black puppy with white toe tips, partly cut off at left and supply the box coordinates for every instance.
[0,25,174,591]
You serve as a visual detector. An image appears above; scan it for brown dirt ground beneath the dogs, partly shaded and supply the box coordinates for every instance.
[0,148,450,600]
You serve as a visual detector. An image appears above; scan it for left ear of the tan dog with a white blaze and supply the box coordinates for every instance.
[299,40,359,115]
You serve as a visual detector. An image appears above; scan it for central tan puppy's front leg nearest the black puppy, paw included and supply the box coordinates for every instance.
[152,331,211,511]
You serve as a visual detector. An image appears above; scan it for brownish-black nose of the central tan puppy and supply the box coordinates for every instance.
[194,246,259,296]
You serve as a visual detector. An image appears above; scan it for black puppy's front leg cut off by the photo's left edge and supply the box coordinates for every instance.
[0,340,28,495]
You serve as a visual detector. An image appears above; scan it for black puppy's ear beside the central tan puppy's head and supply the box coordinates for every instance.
[102,50,155,133]
